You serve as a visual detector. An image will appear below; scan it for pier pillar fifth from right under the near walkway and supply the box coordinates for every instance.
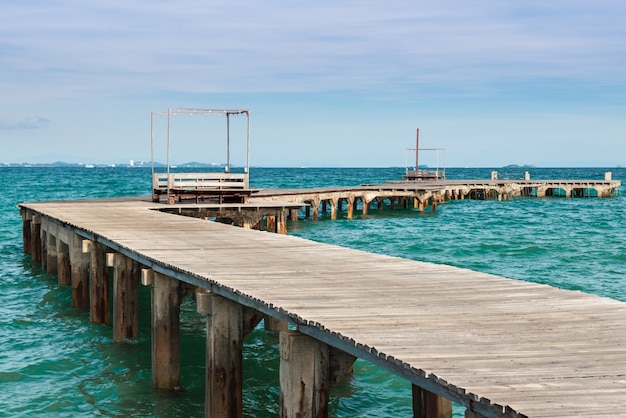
[108,254,141,341]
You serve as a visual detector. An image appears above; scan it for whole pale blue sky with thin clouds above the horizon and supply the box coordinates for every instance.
[0,0,626,167]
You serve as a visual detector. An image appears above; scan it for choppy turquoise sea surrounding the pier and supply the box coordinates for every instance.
[0,166,626,417]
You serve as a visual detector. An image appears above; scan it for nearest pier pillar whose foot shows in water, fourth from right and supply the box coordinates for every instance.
[151,272,181,390]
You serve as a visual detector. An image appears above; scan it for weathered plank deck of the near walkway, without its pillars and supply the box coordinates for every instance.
[21,199,626,417]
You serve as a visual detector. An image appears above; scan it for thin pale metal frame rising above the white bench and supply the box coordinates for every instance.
[151,108,250,184]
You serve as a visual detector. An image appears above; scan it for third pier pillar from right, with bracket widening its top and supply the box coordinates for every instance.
[196,291,262,418]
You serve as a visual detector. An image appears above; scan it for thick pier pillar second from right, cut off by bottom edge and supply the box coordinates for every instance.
[280,331,330,418]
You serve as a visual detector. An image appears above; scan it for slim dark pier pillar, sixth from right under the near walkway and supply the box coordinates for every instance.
[89,241,111,324]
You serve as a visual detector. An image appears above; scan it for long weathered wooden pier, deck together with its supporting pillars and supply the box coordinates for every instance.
[20,176,626,418]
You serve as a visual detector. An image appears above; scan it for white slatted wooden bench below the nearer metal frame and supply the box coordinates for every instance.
[152,173,256,204]
